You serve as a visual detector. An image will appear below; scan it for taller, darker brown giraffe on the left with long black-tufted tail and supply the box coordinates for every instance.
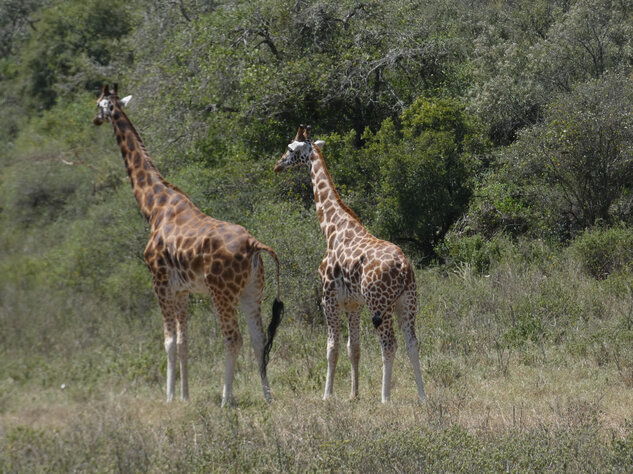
[93,84,283,406]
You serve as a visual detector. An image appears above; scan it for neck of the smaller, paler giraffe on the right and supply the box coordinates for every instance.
[310,148,364,242]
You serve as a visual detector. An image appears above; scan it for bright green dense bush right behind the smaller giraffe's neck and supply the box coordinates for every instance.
[369,98,484,255]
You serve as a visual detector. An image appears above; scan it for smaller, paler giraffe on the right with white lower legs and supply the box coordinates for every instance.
[275,125,425,403]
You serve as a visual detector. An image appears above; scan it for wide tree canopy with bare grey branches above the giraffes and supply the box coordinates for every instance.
[132,0,470,155]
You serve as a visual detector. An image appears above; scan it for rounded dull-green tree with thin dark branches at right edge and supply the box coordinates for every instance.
[504,73,633,237]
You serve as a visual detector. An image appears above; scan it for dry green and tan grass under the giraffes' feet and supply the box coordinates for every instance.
[0,246,633,472]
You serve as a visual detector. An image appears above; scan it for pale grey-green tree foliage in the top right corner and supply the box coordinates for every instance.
[472,0,632,145]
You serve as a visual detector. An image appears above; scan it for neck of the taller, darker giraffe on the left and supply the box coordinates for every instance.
[111,107,188,223]
